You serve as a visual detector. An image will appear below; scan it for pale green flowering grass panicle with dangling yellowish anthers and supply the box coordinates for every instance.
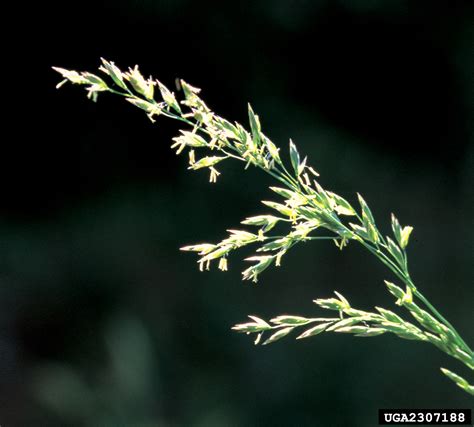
[54,59,474,395]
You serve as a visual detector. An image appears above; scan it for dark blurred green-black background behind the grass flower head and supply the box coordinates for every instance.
[0,0,474,427]
